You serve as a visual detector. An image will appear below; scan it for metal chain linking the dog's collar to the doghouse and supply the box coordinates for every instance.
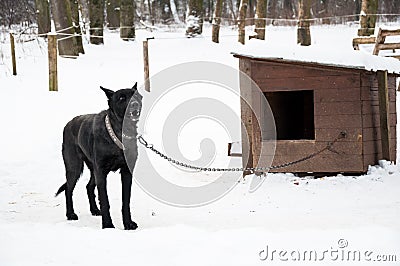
[137,131,347,172]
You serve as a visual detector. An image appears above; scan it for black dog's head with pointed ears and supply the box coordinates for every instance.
[100,83,142,121]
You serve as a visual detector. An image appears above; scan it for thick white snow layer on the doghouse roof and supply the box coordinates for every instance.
[233,40,400,74]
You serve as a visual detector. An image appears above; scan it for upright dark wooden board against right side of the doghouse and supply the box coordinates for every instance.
[377,70,391,161]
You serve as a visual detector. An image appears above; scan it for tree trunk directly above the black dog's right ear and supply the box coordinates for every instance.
[120,0,135,41]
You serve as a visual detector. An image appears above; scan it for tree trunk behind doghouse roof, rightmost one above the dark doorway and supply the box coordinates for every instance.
[297,0,312,46]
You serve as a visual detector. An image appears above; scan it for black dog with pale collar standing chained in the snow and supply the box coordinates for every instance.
[56,84,142,230]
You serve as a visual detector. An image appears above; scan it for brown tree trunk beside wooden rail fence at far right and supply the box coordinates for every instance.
[358,0,378,36]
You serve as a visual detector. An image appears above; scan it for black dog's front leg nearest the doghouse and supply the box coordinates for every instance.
[121,167,137,230]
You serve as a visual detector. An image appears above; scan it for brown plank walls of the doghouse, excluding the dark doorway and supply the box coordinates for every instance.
[235,55,397,173]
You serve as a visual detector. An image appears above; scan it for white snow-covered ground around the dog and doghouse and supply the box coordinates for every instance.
[0,25,400,266]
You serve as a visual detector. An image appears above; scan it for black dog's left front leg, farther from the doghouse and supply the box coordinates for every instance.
[95,169,114,229]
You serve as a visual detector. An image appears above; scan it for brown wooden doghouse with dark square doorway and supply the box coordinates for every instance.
[234,54,400,173]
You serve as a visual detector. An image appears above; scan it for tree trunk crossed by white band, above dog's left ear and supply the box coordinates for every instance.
[89,0,104,44]
